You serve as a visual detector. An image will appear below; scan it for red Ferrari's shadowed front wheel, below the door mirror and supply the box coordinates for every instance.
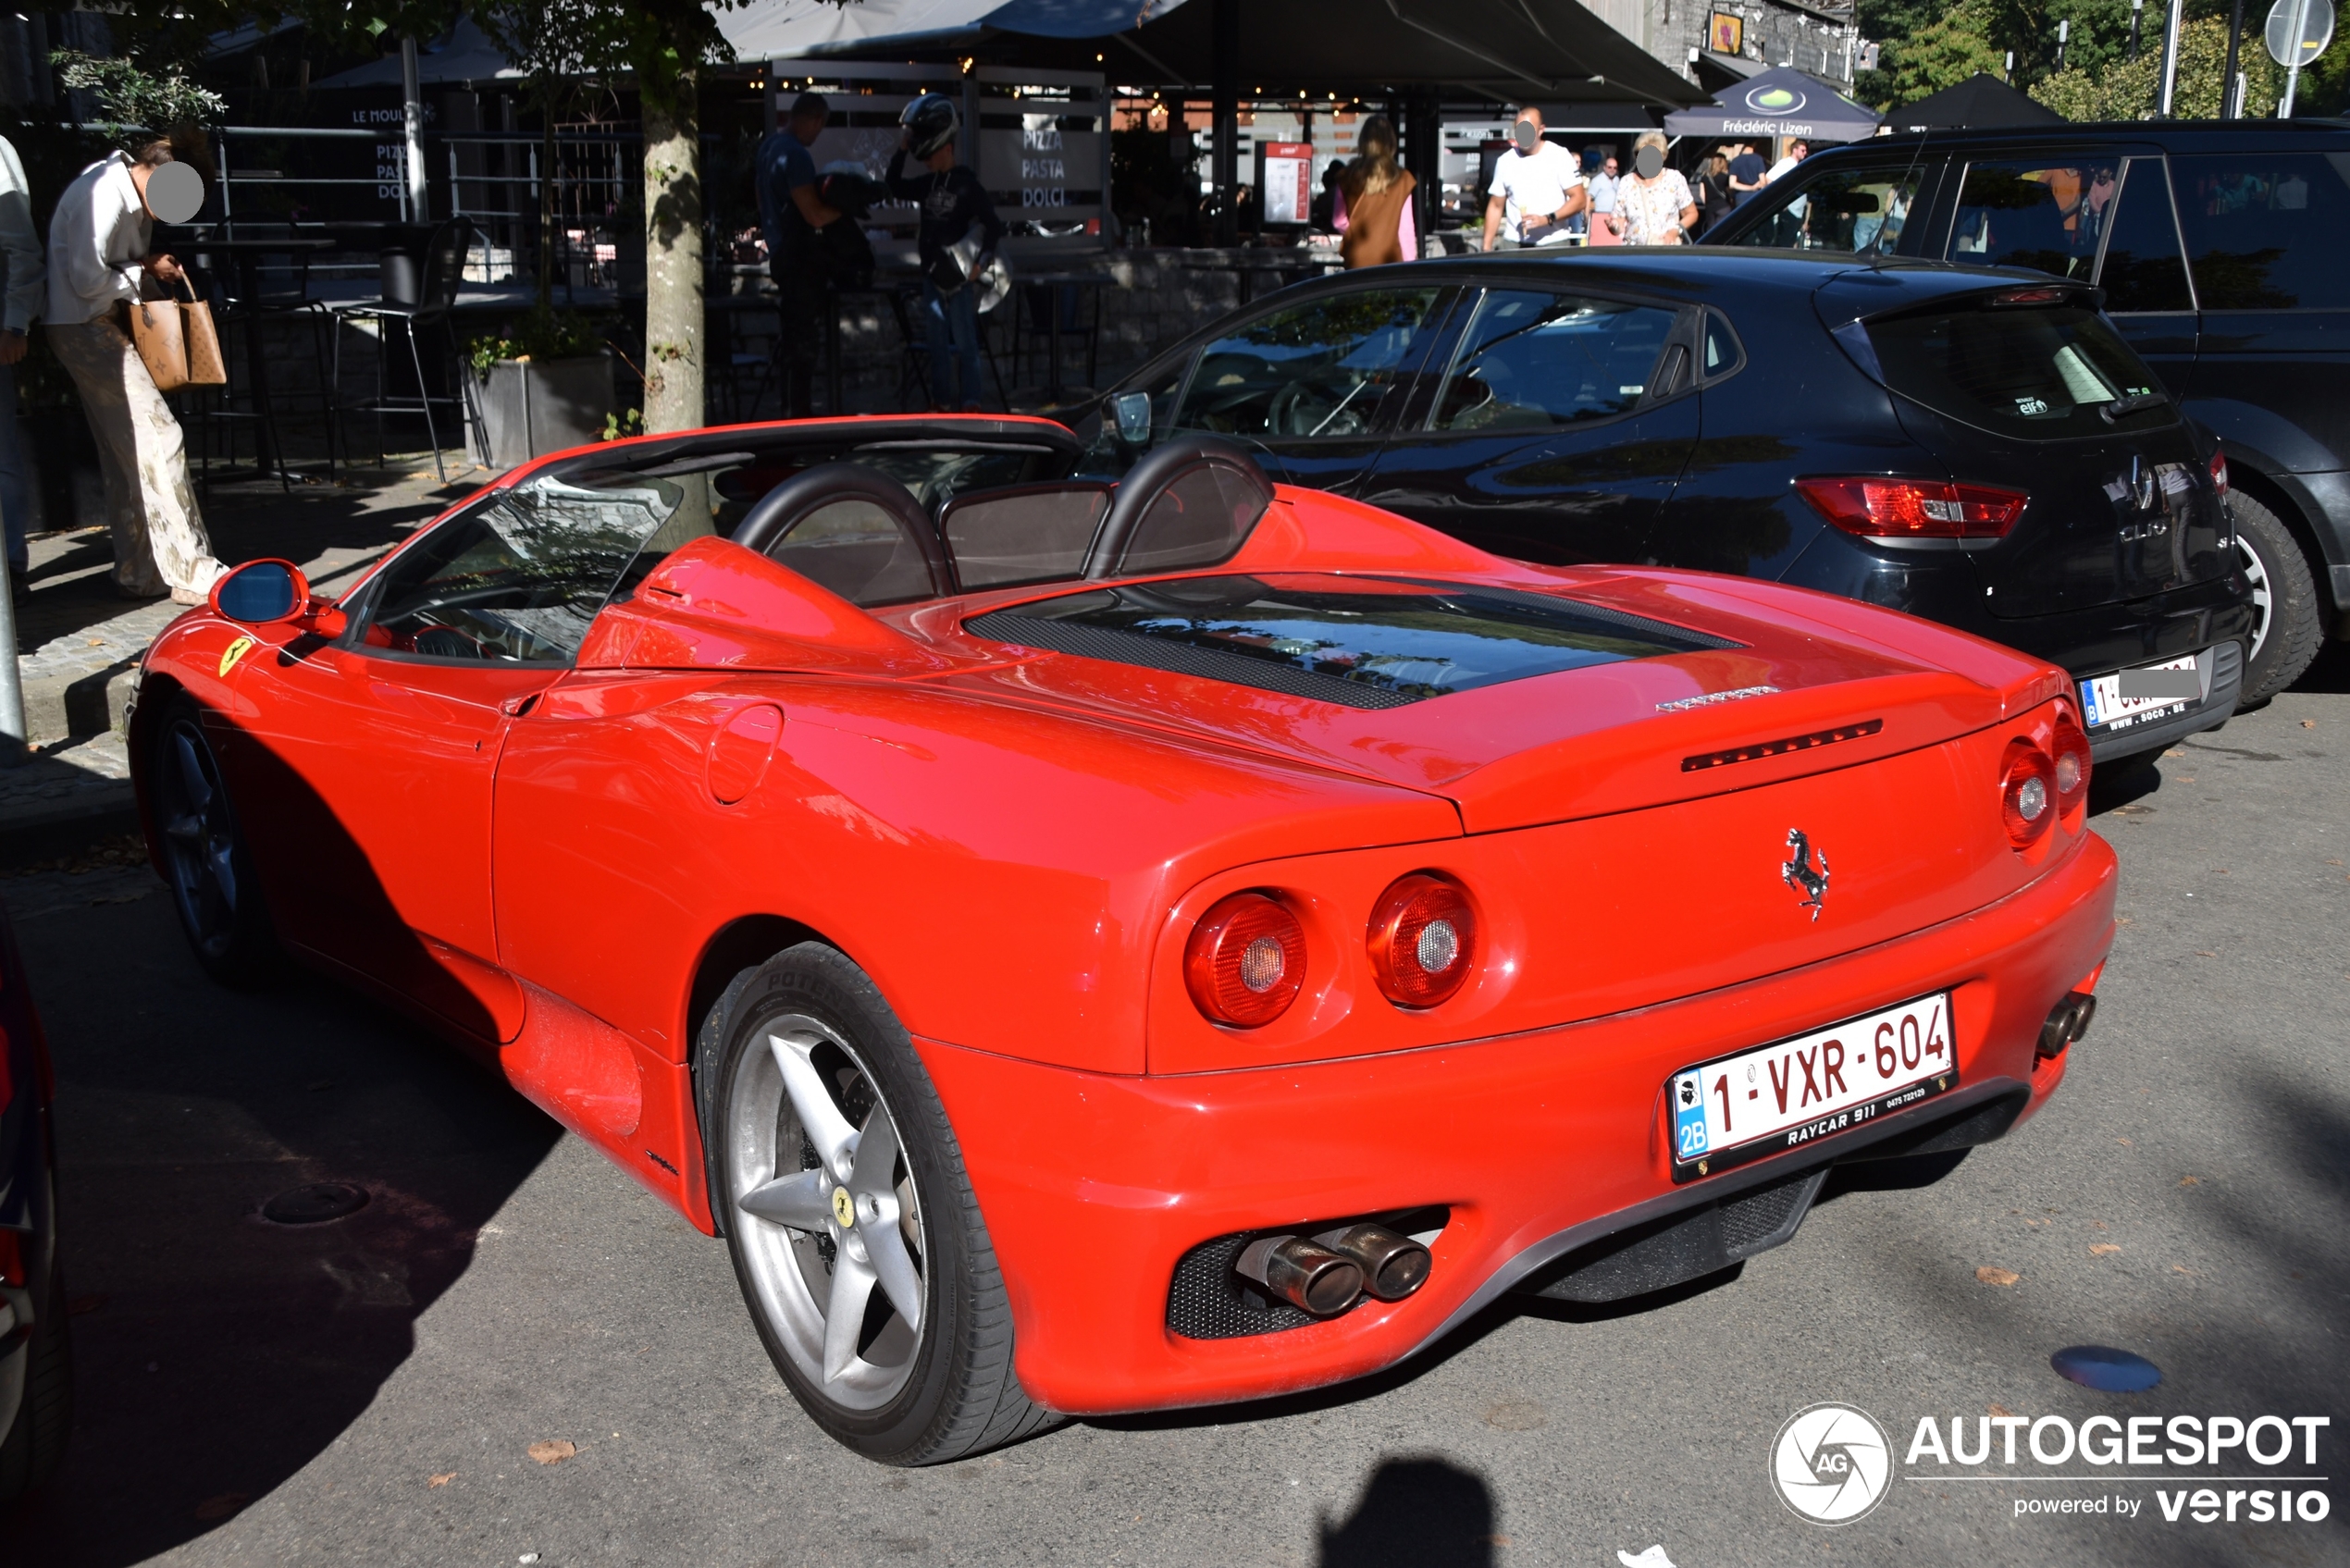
[145,696,278,985]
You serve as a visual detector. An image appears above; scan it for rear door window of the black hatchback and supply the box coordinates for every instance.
[1429,290,1678,430]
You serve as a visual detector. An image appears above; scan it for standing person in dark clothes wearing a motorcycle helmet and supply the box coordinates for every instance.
[888,92,1004,409]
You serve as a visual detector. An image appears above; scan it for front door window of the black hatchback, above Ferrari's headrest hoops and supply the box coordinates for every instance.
[1154,287,1443,439]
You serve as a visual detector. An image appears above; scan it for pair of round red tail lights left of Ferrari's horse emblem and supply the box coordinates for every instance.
[1182,872,1476,1030]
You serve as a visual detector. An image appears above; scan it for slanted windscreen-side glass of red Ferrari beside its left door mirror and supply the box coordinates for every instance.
[357,477,681,663]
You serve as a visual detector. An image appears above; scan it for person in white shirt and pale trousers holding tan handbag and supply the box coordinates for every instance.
[47,141,221,604]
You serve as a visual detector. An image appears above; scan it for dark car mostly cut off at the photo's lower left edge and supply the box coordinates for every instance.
[0,917,70,1514]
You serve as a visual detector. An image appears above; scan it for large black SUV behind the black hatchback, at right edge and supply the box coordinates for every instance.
[1706,120,2350,700]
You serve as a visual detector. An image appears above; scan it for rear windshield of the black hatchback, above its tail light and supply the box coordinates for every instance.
[1868,290,2179,439]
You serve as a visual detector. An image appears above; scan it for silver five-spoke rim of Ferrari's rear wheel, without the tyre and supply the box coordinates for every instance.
[726,1013,928,1411]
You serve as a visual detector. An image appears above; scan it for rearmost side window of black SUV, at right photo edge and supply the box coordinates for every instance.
[2171,153,2350,310]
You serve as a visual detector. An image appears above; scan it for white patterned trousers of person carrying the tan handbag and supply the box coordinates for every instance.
[47,315,223,599]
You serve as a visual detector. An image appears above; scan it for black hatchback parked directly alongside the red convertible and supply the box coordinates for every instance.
[1081,249,2254,759]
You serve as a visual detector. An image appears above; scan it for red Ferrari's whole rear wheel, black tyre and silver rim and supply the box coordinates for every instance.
[698,943,1055,1464]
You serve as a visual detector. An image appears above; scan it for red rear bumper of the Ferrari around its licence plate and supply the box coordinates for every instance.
[917,834,2115,1415]
